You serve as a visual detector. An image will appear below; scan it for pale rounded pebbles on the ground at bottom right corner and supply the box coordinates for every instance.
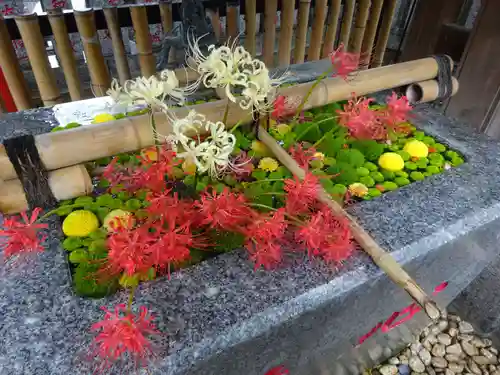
[371,314,500,375]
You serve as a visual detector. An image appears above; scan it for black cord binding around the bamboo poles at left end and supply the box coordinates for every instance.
[3,134,57,209]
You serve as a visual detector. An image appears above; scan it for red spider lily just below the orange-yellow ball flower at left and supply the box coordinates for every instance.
[101,224,155,276]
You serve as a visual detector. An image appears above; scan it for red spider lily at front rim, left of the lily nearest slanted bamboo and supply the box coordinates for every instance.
[245,208,288,269]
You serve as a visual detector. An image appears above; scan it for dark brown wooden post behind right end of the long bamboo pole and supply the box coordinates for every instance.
[399,0,464,62]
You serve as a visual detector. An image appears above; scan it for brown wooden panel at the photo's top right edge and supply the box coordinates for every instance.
[445,0,500,139]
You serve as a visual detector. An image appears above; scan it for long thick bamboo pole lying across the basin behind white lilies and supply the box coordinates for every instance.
[0,58,451,180]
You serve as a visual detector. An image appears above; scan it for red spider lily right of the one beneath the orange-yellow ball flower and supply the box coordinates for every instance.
[146,225,200,278]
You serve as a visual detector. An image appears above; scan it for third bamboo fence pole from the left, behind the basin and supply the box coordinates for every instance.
[47,8,82,101]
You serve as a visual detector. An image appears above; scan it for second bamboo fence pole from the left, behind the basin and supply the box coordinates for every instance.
[16,14,62,106]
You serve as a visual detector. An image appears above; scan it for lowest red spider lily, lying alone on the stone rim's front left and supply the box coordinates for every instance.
[91,304,160,368]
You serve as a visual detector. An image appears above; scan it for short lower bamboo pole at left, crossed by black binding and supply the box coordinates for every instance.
[0,165,92,214]
